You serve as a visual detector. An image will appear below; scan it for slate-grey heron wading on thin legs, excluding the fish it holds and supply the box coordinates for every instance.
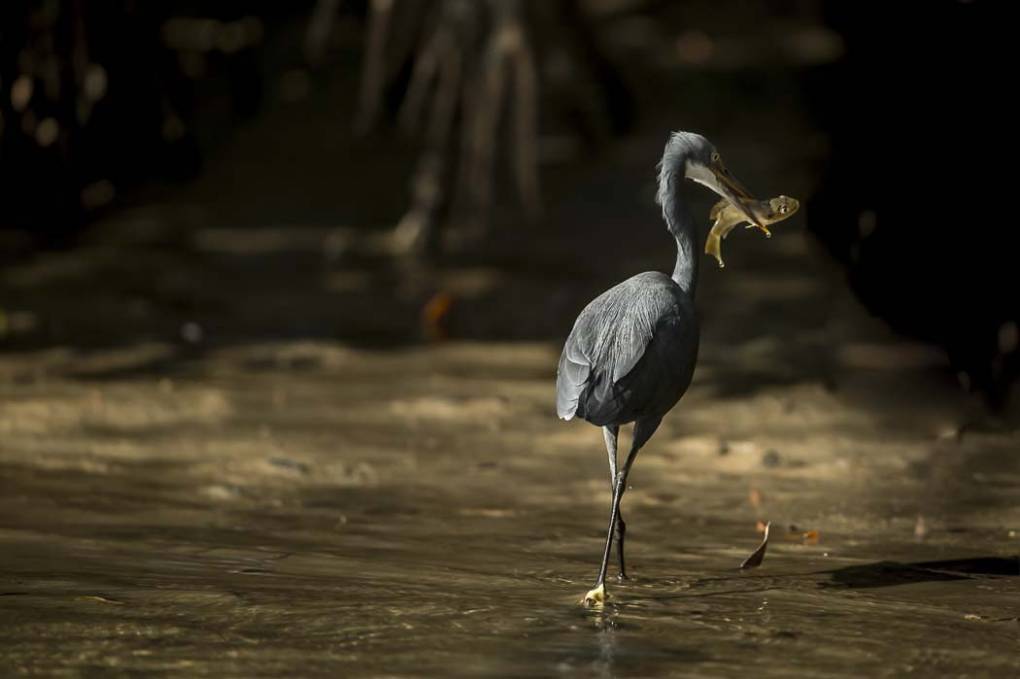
[556,132,763,606]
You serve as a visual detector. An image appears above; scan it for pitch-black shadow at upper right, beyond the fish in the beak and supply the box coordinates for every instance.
[805,2,1020,408]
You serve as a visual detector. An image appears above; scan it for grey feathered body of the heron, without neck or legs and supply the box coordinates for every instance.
[556,272,698,425]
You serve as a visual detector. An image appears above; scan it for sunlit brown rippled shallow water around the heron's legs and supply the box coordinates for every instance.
[0,336,1020,677]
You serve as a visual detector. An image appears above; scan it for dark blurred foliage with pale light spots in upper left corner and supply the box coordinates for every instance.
[0,0,275,244]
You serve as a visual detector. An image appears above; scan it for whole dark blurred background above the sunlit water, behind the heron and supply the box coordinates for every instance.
[0,0,1020,410]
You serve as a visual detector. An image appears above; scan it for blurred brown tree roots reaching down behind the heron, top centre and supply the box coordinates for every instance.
[350,0,634,254]
